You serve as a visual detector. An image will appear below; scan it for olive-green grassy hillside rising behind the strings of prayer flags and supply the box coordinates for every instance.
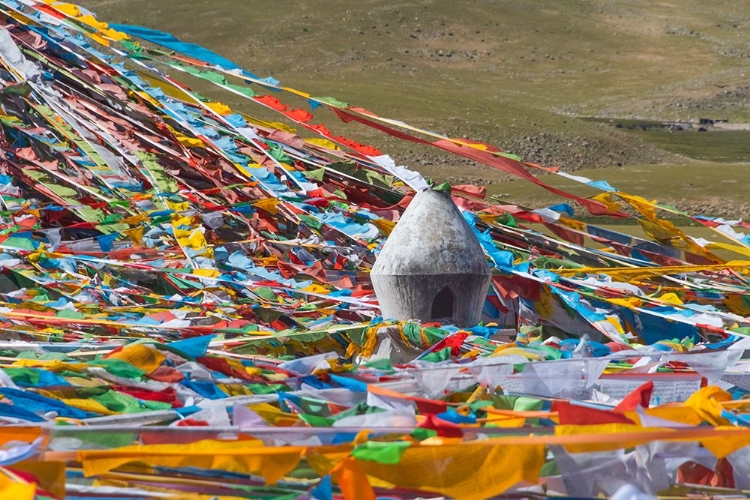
[80,0,750,215]
